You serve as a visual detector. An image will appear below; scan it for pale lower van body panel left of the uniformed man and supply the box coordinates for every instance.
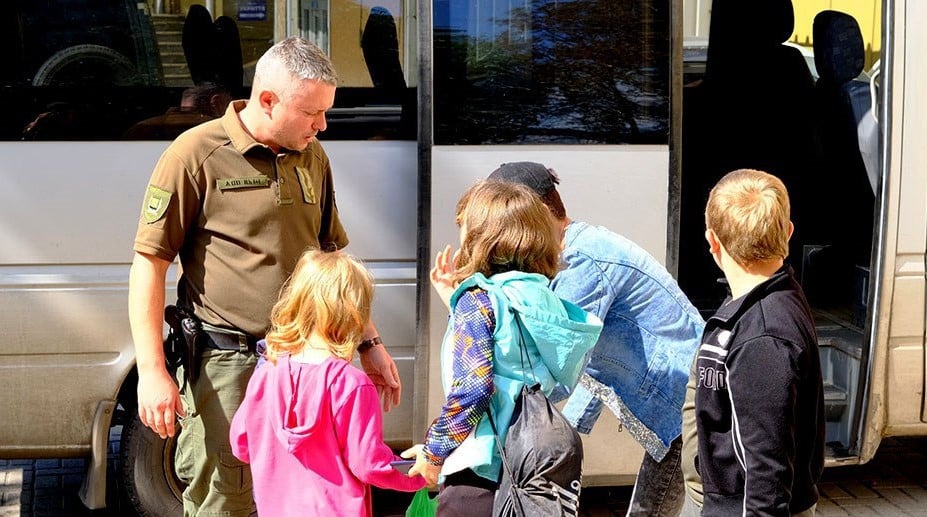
[0,142,156,457]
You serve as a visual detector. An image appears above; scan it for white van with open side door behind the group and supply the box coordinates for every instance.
[0,0,927,515]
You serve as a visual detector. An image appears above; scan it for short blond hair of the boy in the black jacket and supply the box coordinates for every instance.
[705,169,790,265]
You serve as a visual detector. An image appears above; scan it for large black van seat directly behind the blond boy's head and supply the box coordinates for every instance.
[679,0,815,305]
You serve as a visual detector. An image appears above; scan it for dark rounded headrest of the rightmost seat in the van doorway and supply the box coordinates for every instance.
[812,11,866,84]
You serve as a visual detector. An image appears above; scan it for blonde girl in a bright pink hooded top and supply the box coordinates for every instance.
[229,251,425,516]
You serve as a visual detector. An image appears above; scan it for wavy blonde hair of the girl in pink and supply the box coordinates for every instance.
[266,250,373,363]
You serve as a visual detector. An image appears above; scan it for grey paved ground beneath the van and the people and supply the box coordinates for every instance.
[0,437,927,517]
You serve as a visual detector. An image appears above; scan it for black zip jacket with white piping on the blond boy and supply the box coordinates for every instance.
[695,266,824,517]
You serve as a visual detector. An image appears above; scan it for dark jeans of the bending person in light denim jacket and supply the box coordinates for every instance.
[628,437,686,517]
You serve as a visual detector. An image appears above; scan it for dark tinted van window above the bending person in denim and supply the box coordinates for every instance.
[434,0,670,144]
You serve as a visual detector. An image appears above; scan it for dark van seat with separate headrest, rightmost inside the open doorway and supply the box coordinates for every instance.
[805,10,878,305]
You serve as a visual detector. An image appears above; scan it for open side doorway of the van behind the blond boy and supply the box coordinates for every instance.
[679,0,882,457]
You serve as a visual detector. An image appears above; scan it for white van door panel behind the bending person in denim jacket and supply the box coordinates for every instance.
[420,145,669,486]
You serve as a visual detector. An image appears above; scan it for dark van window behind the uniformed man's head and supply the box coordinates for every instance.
[0,0,416,140]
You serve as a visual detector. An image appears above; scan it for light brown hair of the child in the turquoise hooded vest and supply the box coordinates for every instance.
[457,180,560,281]
